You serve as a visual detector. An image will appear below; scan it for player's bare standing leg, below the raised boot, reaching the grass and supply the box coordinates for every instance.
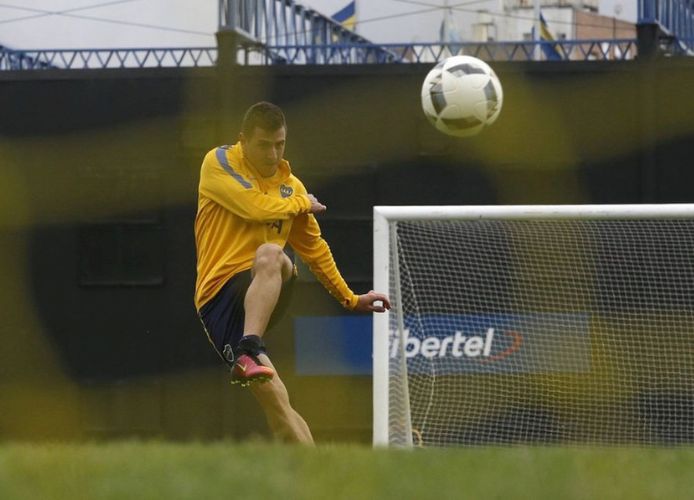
[250,353,313,444]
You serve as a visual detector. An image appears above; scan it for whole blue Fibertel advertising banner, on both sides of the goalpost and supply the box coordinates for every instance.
[294,313,591,375]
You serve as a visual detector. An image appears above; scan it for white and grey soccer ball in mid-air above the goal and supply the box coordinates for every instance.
[422,56,504,137]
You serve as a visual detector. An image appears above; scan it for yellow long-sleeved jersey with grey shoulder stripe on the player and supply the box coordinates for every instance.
[195,143,358,310]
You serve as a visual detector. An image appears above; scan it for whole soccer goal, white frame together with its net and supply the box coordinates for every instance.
[373,204,694,446]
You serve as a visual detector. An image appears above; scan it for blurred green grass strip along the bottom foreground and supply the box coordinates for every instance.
[0,442,694,500]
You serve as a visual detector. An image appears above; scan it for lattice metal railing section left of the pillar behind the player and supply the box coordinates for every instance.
[0,47,217,71]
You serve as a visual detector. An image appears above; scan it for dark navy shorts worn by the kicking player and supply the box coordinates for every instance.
[198,269,295,366]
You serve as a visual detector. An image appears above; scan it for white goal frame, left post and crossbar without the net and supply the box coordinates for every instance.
[373,203,694,446]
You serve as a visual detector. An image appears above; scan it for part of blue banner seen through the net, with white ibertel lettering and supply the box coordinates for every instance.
[390,313,590,375]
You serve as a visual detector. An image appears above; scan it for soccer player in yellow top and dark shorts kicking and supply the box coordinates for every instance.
[195,102,390,443]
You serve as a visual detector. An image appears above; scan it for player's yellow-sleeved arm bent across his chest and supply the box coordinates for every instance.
[200,149,314,221]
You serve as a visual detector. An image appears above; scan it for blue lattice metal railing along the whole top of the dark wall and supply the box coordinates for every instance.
[0,39,637,71]
